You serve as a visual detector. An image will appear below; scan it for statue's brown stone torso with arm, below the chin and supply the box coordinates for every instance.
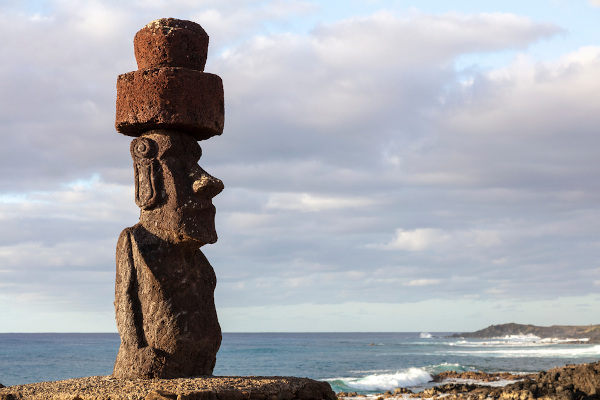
[115,224,221,377]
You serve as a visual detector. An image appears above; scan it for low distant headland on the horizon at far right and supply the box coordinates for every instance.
[451,323,600,343]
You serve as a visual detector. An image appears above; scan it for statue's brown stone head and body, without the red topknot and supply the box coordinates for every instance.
[113,130,223,379]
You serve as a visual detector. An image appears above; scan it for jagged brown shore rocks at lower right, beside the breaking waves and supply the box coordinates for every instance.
[337,362,600,400]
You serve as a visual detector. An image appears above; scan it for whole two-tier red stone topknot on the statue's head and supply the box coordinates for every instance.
[115,18,225,140]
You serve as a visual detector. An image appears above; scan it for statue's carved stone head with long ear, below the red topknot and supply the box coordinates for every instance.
[131,129,224,247]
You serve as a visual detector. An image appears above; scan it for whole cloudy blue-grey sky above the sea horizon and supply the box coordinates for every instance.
[0,0,600,332]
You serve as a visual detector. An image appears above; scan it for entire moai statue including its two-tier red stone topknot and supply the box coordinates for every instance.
[113,18,224,379]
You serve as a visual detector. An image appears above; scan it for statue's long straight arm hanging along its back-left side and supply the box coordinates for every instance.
[115,228,146,348]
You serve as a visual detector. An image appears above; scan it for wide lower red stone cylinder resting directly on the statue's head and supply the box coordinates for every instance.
[115,68,225,140]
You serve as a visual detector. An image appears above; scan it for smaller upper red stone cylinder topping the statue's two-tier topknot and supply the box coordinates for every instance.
[133,18,208,71]
